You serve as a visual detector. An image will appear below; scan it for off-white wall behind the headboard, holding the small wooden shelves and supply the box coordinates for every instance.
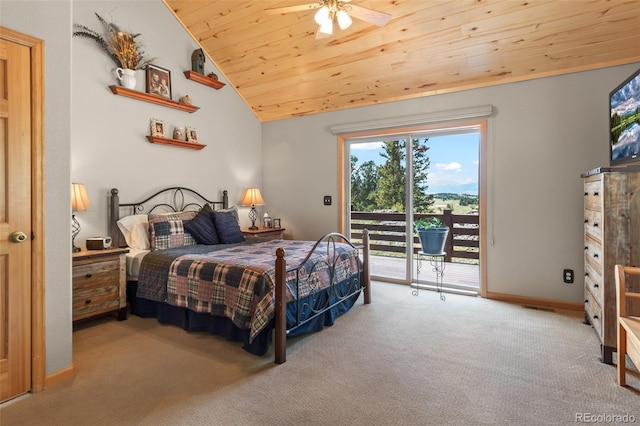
[71,0,262,240]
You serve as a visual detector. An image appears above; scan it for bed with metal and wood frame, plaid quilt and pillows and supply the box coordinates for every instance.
[109,187,371,364]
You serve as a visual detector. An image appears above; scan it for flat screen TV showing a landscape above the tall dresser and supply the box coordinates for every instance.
[609,70,640,166]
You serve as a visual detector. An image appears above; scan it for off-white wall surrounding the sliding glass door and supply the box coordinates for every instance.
[262,64,639,303]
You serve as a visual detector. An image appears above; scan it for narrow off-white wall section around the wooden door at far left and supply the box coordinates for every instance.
[0,0,72,374]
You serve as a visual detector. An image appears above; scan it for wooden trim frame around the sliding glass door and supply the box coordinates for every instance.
[337,116,488,297]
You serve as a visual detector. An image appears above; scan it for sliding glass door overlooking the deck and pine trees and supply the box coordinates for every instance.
[344,126,481,292]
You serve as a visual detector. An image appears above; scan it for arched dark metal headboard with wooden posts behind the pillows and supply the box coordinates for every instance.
[109,186,229,247]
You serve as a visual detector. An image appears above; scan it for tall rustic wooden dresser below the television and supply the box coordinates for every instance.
[582,166,640,364]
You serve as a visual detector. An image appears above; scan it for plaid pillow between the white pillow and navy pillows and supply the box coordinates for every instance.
[149,211,197,250]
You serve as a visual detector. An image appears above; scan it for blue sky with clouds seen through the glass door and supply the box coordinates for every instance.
[351,133,480,194]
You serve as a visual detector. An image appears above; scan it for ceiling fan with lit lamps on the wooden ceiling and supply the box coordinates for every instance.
[266,0,391,39]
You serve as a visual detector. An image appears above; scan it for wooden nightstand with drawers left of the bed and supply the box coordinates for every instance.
[72,248,129,321]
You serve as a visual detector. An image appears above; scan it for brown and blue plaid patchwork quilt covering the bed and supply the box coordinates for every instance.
[138,240,359,341]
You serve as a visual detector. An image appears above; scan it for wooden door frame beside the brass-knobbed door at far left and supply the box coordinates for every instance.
[0,26,46,392]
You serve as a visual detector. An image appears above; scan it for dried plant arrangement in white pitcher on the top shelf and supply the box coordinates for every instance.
[73,13,152,70]
